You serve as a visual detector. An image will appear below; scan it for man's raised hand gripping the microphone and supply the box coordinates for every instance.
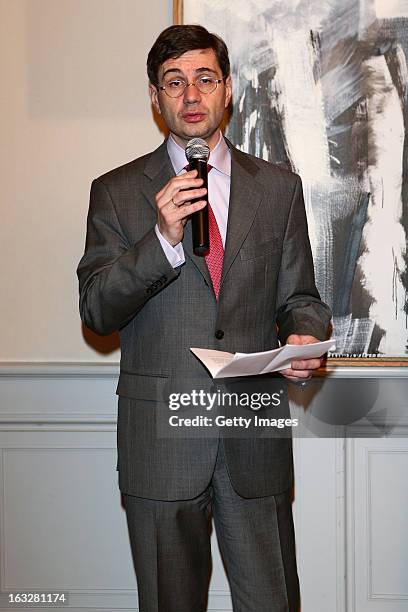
[156,170,207,246]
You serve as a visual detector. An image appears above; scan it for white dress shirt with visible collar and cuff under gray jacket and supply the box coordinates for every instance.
[155,132,231,268]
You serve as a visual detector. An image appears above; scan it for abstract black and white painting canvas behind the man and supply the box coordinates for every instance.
[180,0,408,359]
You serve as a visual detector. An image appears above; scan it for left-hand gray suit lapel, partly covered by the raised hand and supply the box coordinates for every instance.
[142,142,212,288]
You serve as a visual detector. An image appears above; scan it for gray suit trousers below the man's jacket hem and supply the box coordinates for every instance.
[123,439,300,612]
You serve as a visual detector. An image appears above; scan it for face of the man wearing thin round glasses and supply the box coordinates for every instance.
[149,49,231,149]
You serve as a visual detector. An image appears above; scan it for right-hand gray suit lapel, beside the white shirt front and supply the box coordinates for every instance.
[220,140,263,291]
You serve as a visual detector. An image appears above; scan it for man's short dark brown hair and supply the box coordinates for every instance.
[147,25,230,87]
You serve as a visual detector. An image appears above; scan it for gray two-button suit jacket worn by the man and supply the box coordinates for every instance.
[78,143,330,499]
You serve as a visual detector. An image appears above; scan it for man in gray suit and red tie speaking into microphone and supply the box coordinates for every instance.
[78,26,330,612]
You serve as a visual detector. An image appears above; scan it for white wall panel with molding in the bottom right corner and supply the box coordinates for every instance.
[346,438,408,612]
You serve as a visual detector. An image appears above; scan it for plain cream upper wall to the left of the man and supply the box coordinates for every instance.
[0,0,172,362]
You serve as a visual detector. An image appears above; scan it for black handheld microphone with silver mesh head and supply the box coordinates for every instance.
[186,138,210,257]
